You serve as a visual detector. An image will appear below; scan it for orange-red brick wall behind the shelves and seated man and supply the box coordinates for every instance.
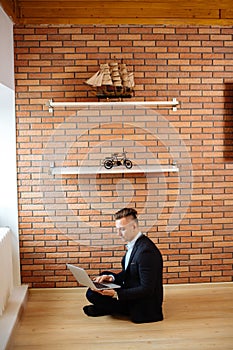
[15,26,233,287]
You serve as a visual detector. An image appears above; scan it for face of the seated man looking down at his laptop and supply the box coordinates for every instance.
[116,216,138,242]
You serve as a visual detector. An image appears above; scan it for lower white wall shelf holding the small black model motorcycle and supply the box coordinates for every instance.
[50,165,179,175]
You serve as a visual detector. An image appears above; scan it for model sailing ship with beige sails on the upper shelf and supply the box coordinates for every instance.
[85,60,135,98]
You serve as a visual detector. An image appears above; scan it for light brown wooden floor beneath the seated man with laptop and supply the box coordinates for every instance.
[12,283,233,350]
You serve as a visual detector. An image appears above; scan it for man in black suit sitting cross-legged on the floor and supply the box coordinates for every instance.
[83,208,163,323]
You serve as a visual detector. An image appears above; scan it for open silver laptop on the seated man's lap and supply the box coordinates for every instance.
[66,264,121,290]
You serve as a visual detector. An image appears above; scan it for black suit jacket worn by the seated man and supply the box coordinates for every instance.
[114,235,163,323]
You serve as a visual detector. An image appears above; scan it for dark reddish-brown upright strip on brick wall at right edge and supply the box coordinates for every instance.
[224,83,233,162]
